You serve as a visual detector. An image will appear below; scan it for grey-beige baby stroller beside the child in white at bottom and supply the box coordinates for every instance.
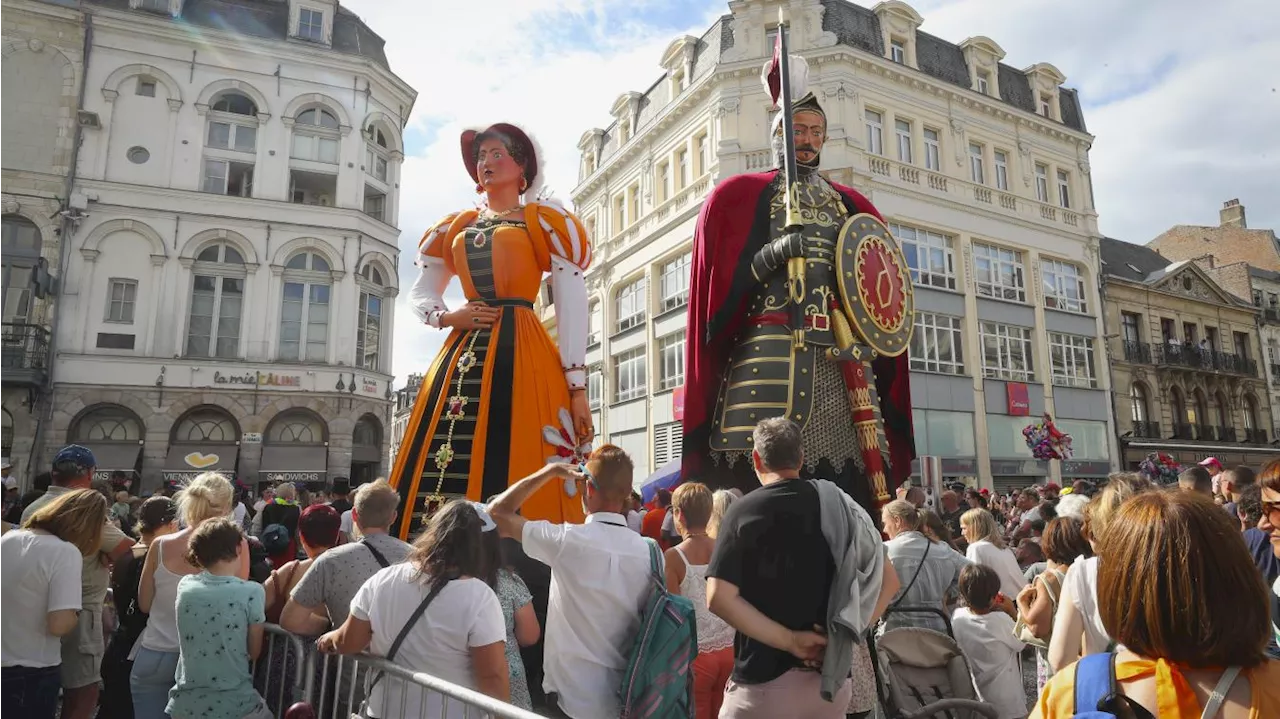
[870,606,998,719]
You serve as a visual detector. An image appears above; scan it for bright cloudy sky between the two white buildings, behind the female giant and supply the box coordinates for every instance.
[343,0,724,385]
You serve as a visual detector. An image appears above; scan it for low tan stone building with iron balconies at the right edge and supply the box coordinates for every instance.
[1102,238,1280,468]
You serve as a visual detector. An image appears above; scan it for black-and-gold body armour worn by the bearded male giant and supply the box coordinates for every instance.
[710,175,847,452]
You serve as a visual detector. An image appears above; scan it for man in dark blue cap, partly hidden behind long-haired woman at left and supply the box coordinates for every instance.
[22,444,133,719]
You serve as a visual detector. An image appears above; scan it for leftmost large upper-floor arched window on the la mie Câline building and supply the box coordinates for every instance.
[200,92,259,197]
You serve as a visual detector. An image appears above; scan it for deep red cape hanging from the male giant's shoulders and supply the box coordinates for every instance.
[681,170,915,481]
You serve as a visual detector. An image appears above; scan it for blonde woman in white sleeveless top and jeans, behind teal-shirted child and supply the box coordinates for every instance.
[129,472,248,719]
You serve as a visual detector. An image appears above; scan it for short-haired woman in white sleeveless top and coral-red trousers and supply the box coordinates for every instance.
[666,482,733,719]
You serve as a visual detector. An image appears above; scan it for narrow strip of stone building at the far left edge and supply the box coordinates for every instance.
[0,0,84,480]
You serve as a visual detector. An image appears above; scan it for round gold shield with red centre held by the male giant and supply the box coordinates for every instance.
[836,214,915,357]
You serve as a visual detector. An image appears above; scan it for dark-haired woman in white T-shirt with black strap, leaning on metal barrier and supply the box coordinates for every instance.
[316,500,511,719]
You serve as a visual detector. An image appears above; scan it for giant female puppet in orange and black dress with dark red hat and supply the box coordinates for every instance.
[392,124,594,537]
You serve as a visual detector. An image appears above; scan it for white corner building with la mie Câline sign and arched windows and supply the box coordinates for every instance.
[46,0,415,489]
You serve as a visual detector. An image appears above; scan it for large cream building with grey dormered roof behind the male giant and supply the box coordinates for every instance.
[558,0,1116,486]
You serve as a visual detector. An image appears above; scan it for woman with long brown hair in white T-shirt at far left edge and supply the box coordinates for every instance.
[0,489,106,719]
